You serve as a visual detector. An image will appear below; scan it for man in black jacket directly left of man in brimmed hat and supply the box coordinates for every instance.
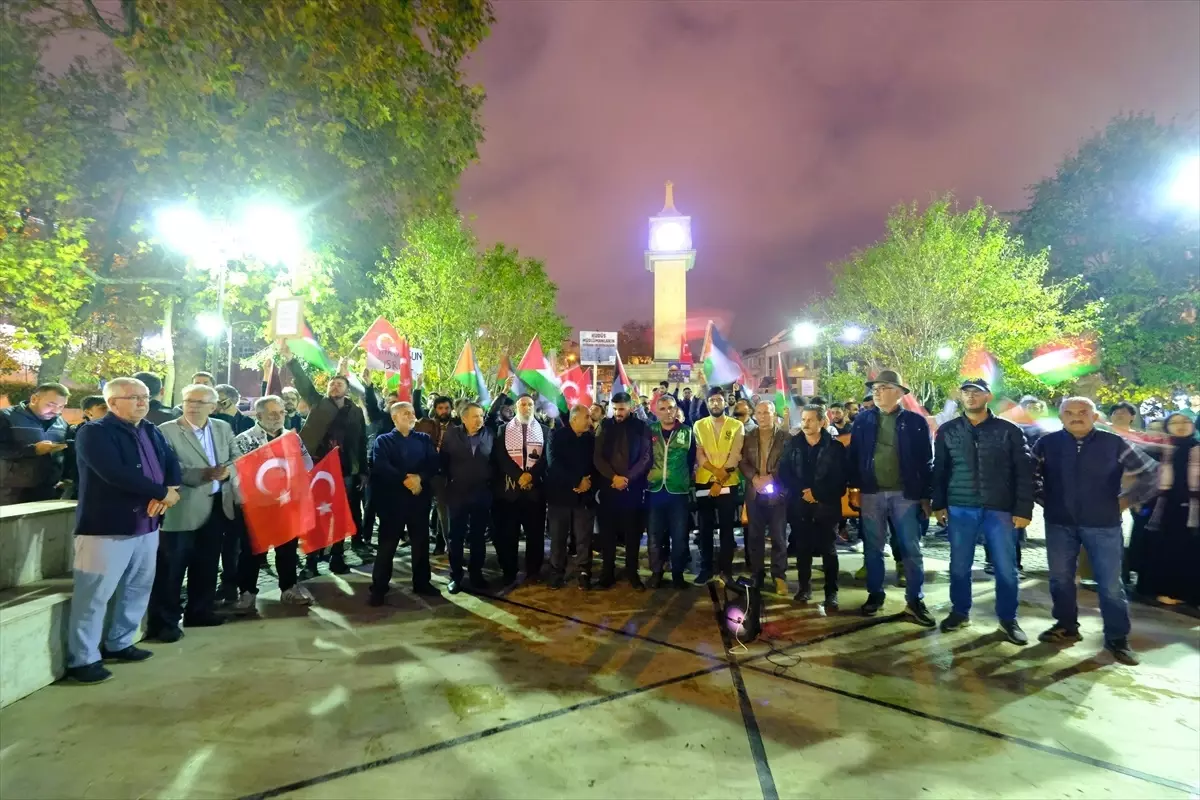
[779,405,847,610]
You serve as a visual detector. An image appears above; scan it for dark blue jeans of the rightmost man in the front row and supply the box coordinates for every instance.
[1046,524,1129,642]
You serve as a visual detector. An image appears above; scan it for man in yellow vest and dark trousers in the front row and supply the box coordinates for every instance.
[692,386,745,584]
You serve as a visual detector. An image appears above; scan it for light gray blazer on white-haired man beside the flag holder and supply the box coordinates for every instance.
[158,417,234,530]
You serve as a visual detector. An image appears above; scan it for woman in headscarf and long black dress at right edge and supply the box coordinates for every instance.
[1138,411,1200,606]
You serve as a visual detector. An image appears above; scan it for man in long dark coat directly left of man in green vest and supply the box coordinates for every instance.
[594,392,652,589]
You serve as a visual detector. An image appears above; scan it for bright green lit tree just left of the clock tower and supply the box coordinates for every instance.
[372,213,570,387]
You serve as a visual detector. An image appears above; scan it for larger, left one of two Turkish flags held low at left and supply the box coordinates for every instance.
[233,431,313,554]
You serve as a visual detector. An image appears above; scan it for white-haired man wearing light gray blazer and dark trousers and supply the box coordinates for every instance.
[146,384,234,643]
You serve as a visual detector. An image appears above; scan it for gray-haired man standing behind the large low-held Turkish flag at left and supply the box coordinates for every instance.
[233,395,313,613]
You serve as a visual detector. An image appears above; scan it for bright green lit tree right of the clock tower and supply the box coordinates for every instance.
[811,196,1098,403]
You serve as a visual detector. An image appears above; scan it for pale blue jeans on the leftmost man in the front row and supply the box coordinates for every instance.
[67,530,158,667]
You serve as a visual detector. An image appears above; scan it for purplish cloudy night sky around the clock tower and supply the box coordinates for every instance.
[460,0,1200,348]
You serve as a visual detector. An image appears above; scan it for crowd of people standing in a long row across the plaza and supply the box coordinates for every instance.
[0,357,1200,682]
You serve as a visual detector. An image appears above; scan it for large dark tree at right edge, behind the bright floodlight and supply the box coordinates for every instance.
[1015,114,1200,399]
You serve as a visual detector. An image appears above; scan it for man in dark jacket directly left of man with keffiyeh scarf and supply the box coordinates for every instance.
[439,403,499,595]
